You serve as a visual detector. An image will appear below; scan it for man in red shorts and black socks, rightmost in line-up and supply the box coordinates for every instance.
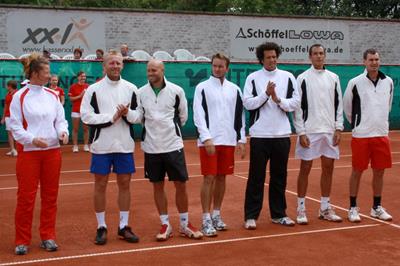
[343,49,394,222]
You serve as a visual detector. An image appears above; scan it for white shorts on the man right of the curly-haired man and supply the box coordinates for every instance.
[295,133,339,161]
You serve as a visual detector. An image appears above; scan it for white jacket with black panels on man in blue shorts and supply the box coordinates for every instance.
[81,76,141,154]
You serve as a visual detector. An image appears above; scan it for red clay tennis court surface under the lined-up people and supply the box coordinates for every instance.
[0,131,400,265]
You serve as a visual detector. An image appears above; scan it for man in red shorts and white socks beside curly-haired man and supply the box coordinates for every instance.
[193,53,246,236]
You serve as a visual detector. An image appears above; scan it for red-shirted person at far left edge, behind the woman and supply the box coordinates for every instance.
[1,80,18,157]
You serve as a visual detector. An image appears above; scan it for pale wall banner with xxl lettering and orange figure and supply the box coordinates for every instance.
[7,10,105,56]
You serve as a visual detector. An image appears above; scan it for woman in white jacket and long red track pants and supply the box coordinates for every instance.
[10,54,68,255]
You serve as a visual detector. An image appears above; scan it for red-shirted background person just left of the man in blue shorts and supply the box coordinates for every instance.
[68,71,89,152]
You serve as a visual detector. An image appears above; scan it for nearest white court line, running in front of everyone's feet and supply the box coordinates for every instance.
[0,224,380,266]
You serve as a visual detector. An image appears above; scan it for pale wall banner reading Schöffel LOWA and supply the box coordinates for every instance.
[230,18,350,60]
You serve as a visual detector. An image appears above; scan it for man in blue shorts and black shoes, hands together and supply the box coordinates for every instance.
[81,51,141,245]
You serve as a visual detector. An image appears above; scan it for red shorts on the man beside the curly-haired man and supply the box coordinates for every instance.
[200,145,235,176]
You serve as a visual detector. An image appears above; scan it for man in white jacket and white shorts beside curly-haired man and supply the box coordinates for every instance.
[294,44,343,224]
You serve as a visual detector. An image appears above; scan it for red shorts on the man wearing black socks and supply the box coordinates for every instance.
[351,137,392,171]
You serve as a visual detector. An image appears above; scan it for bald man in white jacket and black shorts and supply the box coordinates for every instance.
[139,59,203,241]
